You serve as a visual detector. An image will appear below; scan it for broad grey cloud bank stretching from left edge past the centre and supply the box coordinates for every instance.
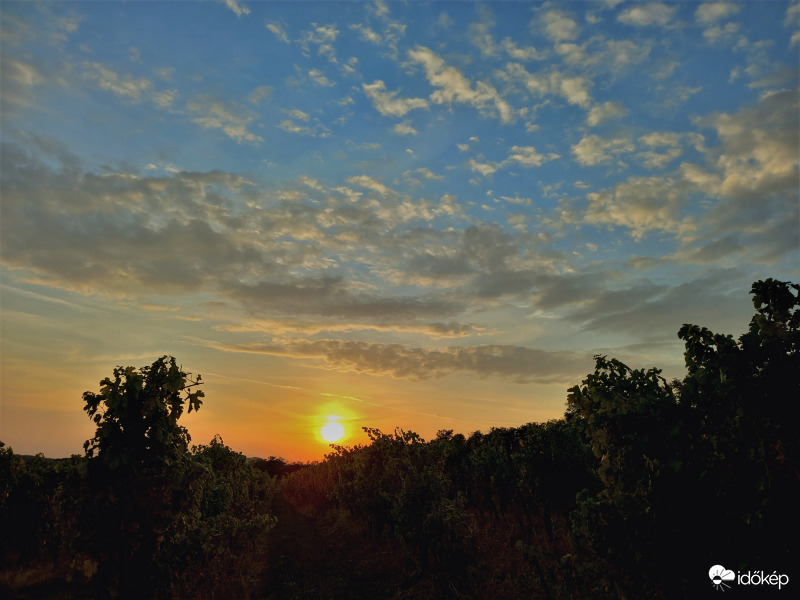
[0,146,482,337]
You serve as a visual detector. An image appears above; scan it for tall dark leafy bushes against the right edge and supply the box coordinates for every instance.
[568,279,800,596]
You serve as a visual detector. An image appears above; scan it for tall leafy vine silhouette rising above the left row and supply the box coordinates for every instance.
[83,356,204,599]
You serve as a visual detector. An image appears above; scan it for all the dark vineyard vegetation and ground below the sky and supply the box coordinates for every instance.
[0,280,800,600]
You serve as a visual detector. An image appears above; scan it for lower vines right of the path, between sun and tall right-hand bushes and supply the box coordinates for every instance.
[281,420,596,597]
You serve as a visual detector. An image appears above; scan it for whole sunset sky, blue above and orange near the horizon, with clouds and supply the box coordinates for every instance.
[0,0,800,461]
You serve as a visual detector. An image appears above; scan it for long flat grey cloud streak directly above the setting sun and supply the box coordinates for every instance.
[213,339,592,384]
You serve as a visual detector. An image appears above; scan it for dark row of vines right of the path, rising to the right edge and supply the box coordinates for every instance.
[284,280,800,598]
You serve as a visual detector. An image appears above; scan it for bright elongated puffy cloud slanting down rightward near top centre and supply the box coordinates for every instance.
[408,46,516,123]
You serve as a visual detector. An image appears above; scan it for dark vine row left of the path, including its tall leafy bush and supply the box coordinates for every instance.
[0,357,277,599]
